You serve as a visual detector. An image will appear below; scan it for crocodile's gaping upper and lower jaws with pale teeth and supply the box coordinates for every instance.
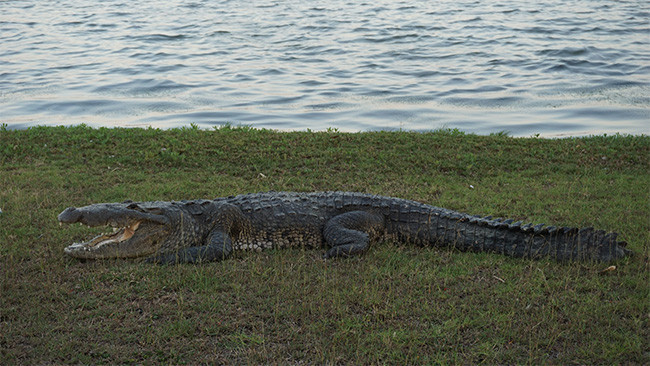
[58,203,169,259]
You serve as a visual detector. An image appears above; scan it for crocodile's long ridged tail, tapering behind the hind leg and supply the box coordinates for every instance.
[400,209,632,262]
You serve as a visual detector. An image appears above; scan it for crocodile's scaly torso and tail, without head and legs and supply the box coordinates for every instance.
[216,192,630,261]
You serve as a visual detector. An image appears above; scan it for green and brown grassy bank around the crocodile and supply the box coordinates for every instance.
[0,126,650,364]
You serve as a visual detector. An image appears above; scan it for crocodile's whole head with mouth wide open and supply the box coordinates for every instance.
[58,201,199,259]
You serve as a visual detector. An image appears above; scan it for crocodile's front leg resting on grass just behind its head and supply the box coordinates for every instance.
[147,231,232,264]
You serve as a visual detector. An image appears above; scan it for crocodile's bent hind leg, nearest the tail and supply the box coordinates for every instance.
[323,211,384,258]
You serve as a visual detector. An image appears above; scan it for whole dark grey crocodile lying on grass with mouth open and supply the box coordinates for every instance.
[58,192,632,264]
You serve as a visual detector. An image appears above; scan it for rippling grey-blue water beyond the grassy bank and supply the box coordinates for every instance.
[0,0,650,136]
